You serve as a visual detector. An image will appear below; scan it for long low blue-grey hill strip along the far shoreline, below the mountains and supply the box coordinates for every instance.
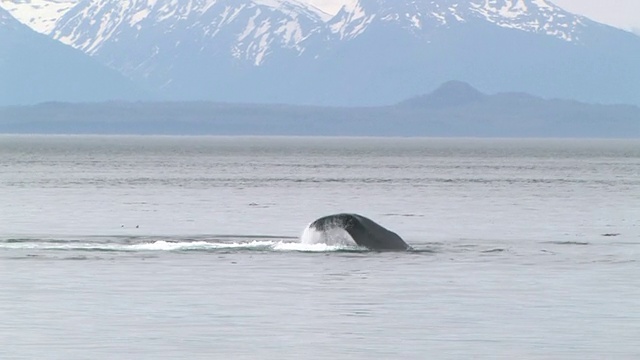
[0,82,640,138]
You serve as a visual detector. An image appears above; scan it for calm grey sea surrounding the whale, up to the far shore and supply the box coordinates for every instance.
[0,135,640,359]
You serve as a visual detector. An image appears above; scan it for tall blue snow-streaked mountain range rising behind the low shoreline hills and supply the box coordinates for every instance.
[0,0,640,106]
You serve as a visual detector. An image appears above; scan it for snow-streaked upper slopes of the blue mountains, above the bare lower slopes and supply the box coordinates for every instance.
[50,0,583,76]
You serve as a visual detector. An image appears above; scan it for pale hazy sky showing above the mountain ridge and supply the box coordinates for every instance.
[309,0,640,32]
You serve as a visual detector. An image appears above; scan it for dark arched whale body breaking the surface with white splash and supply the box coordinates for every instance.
[309,213,412,251]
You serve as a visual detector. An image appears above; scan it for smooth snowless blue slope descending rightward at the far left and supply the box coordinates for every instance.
[0,8,144,105]
